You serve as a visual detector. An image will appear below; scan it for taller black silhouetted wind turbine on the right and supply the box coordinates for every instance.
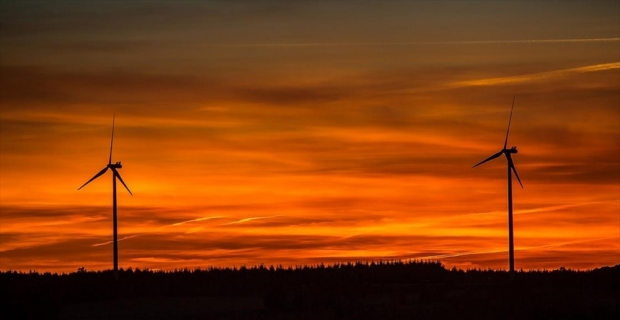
[472,97,523,279]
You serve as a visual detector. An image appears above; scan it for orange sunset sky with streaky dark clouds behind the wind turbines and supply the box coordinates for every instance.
[0,1,620,272]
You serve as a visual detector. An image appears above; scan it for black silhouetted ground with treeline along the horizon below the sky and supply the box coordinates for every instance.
[0,262,620,319]
